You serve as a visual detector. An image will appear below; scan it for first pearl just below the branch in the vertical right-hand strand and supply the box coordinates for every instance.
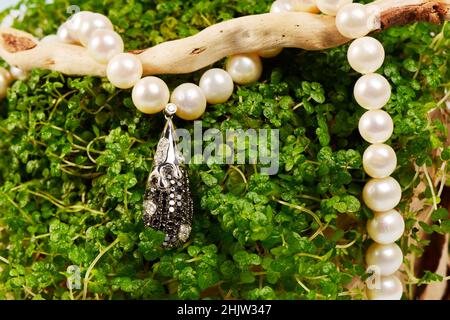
[347,37,385,74]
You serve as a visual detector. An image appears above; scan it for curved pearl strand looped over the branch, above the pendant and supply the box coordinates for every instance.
[46,4,312,120]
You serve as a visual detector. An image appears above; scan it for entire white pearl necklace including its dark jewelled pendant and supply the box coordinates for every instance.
[0,0,405,300]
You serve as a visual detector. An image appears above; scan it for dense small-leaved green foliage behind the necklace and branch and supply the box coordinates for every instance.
[0,0,450,299]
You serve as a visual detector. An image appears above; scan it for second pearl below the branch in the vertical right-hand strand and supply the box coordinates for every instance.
[354,73,391,110]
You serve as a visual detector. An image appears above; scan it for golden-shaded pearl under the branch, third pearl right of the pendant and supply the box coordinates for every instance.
[226,53,262,84]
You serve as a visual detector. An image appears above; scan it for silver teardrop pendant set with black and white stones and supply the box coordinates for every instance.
[143,103,194,247]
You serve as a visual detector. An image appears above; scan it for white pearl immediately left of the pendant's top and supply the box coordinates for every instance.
[132,77,170,114]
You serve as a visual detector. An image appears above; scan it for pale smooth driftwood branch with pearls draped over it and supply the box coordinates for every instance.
[0,0,450,76]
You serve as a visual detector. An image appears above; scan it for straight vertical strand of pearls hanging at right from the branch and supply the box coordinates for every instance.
[317,0,405,300]
